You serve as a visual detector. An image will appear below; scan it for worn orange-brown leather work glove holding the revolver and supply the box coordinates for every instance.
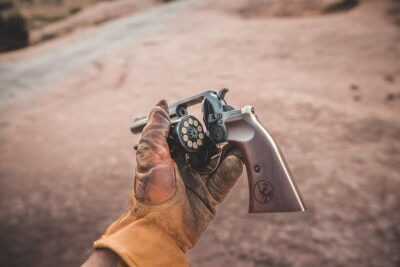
[94,100,243,267]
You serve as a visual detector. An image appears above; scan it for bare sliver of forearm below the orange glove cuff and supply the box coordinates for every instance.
[82,249,127,267]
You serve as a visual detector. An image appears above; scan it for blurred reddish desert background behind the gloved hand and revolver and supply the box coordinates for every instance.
[0,0,400,267]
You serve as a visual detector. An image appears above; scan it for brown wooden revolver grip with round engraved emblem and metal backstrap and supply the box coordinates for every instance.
[225,110,305,213]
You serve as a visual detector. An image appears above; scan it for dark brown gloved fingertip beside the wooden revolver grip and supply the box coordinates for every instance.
[207,150,243,203]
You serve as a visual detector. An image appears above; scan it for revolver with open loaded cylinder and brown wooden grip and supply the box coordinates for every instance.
[131,88,305,213]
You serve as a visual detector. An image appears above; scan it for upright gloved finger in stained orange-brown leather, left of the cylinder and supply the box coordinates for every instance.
[135,100,175,204]
